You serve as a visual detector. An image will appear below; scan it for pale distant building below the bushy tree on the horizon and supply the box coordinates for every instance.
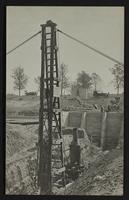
[71,86,93,100]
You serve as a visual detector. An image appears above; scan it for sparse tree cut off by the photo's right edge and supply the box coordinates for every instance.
[110,64,124,95]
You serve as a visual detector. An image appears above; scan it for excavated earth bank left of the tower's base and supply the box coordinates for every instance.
[6,123,38,194]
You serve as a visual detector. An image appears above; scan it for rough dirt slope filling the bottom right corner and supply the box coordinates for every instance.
[63,149,123,196]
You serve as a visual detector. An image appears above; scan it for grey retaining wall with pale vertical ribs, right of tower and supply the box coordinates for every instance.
[65,112,123,149]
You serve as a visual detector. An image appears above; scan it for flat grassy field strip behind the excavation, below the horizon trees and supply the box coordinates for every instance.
[6,95,123,118]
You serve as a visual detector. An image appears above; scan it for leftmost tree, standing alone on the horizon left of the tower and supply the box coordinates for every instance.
[12,67,28,96]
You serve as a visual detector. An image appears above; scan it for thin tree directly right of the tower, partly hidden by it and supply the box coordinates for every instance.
[59,63,70,96]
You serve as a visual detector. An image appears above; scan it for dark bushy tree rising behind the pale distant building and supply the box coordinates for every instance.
[77,71,93,89]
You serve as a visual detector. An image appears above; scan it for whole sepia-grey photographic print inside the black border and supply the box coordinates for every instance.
[5,6,125,196]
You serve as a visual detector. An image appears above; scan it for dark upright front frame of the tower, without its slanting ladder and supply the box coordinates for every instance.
[38,21,57,195]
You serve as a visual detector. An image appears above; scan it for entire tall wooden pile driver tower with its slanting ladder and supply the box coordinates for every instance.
[38,21,65,194]
